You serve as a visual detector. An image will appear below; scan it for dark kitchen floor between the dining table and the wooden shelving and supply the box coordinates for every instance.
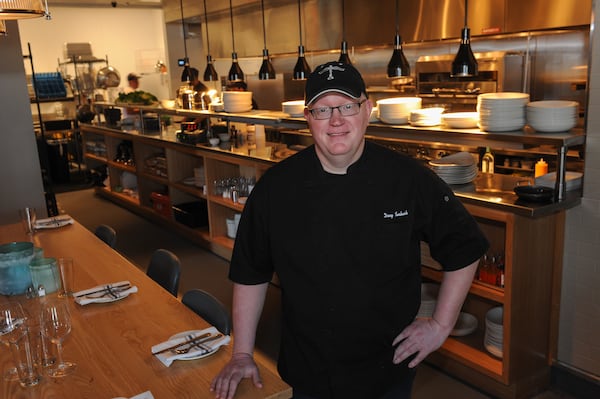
[57,189,574,399]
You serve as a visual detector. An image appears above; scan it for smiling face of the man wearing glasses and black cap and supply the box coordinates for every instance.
[304,93,373,170]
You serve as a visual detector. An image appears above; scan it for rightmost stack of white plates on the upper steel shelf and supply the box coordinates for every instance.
[527,100,579,133]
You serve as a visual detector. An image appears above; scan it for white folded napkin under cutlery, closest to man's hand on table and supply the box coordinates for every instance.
[152,327,231,367]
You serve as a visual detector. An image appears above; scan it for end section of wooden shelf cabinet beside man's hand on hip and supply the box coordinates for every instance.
[423,204,564,398]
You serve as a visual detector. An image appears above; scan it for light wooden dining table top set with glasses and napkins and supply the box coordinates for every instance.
[0,222,291,399]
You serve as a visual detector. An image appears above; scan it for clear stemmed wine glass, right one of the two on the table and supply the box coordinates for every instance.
[40,300,76,377]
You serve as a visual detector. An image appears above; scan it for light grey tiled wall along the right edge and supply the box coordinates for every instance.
[558,1,600,379]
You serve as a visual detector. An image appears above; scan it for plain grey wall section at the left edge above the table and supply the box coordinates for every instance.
[0,21,46,224]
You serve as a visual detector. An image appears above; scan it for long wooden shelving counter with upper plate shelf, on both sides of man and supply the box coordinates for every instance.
[82,104,585,399]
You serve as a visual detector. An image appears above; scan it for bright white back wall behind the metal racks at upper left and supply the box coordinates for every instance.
[18,4,174,98]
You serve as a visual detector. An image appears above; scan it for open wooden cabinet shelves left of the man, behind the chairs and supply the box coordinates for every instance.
[81,125,273,259]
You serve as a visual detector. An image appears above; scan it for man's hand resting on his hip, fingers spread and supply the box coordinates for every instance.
[392,319,451,368]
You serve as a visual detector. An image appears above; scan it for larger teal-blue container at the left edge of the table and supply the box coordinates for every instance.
[0,242,34,295]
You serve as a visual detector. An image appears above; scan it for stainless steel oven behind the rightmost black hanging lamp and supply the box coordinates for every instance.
[415,51,524,112]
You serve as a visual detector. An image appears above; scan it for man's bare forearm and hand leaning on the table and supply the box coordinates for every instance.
[210,283,269,399]
